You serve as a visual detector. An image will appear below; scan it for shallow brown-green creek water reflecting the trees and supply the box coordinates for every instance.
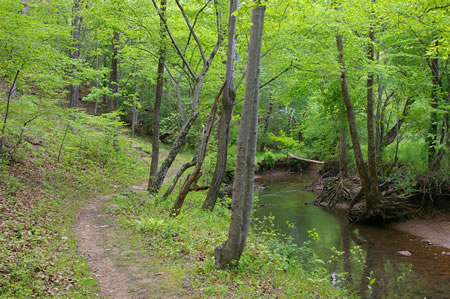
[254,173,450,298]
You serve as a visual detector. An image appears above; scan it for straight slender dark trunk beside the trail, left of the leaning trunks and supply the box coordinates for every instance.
[148,0,167,185]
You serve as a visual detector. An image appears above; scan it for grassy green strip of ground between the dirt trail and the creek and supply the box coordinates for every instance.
[105,188,351,298]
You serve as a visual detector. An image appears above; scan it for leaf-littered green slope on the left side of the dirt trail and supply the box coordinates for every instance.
[0,96,150,298]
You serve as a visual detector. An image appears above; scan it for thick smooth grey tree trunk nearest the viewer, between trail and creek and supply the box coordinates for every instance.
[214,3,266,269]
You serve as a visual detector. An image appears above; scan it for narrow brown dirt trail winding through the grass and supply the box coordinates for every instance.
[73,186,193,299]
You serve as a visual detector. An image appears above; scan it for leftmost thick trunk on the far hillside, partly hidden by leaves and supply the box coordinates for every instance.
[69,0,81,108]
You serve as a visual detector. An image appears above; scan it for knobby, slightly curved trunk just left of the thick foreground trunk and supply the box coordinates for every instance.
[202,0,239,210]
